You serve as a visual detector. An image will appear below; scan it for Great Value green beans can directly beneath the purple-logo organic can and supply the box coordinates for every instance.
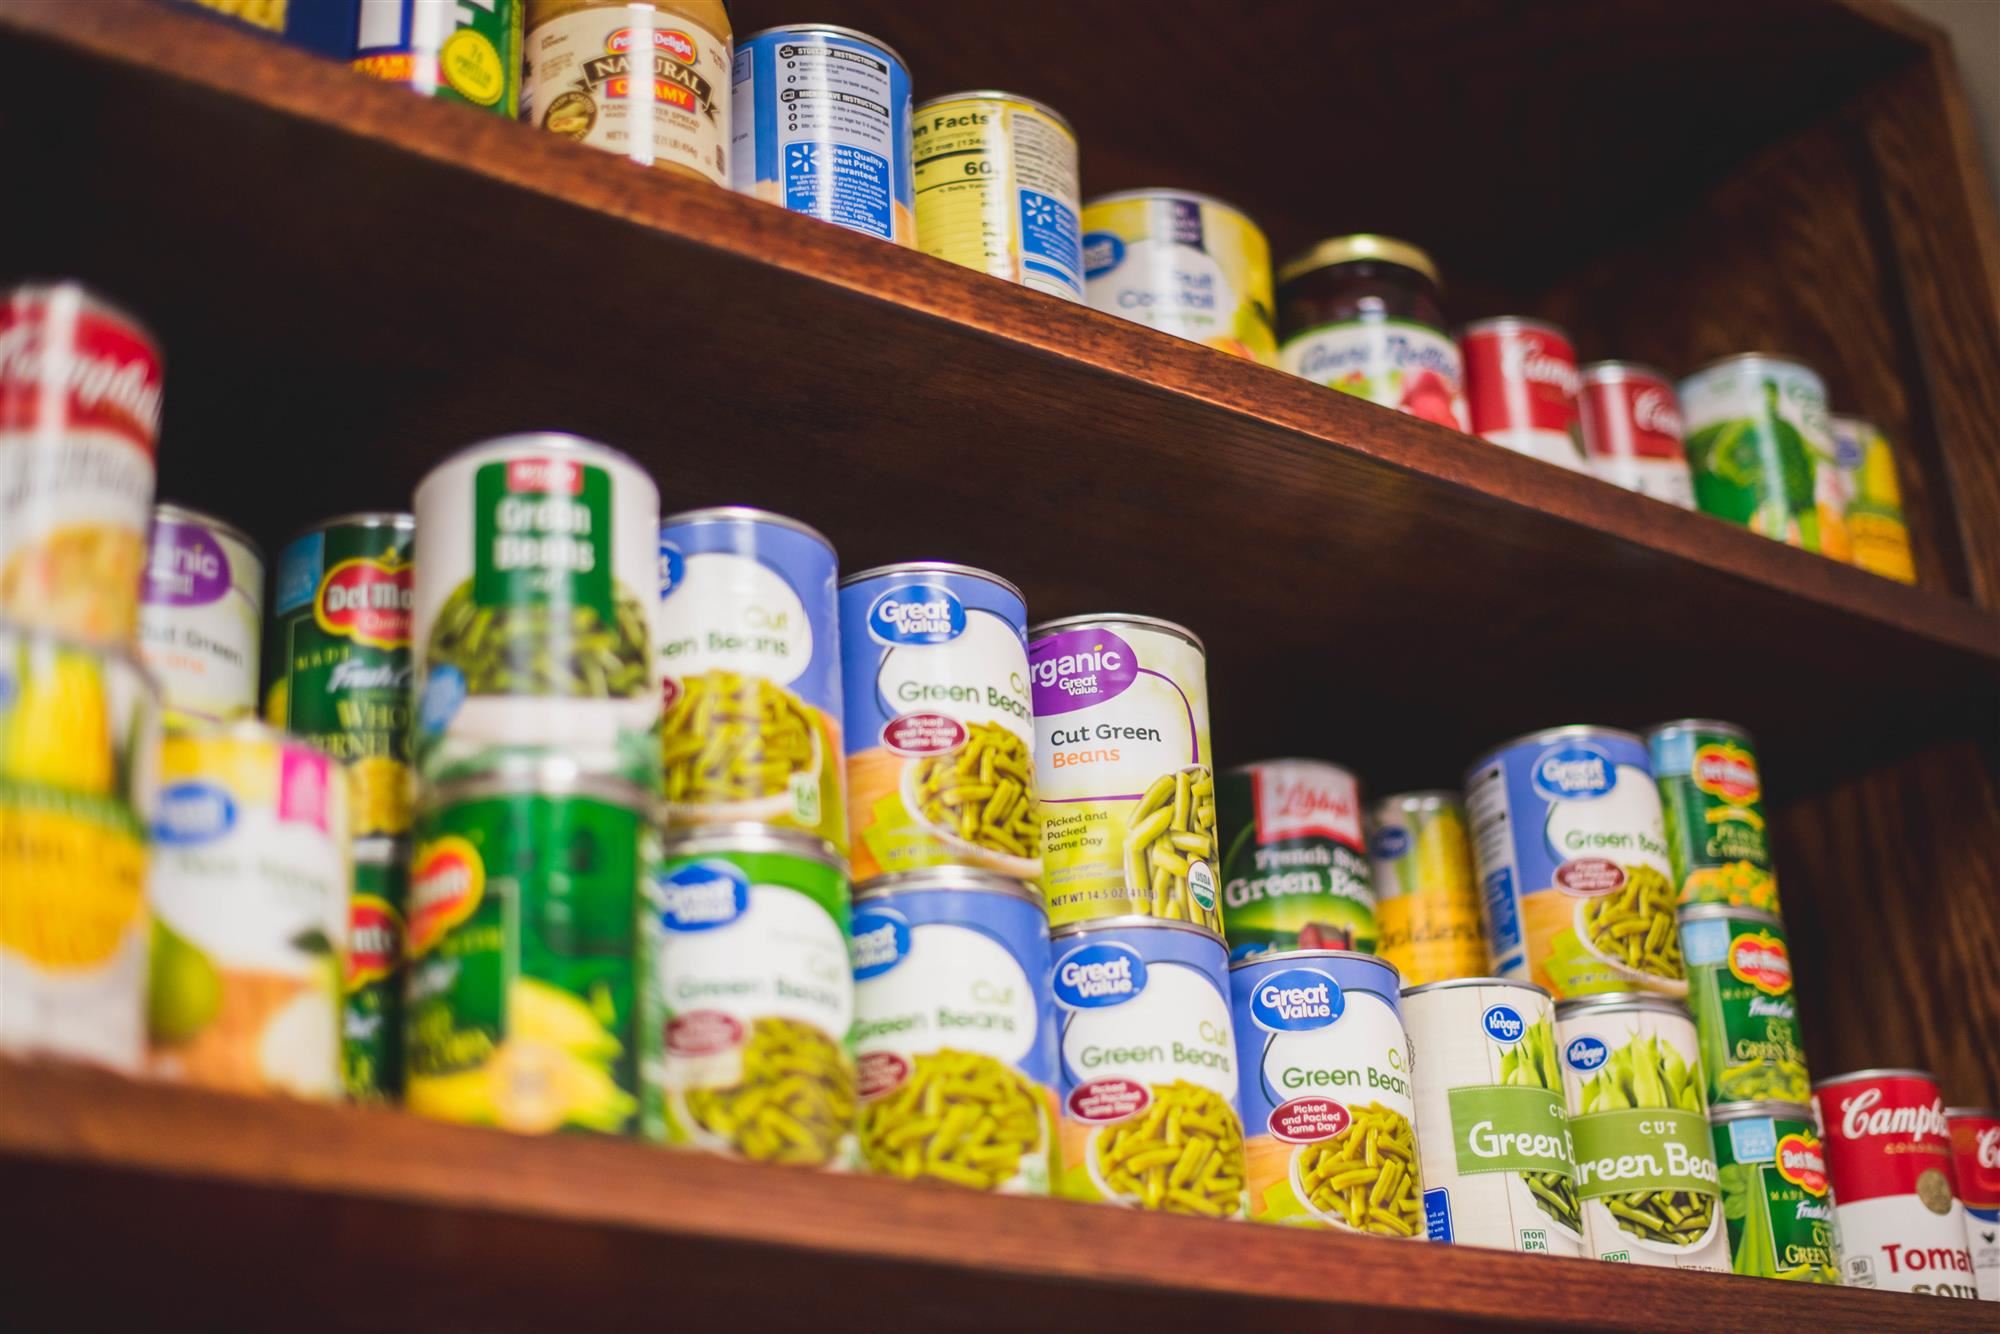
[1050,918,1244,1218]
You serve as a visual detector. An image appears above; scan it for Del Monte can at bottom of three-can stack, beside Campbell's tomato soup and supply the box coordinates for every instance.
[1708,1102,1840,1284]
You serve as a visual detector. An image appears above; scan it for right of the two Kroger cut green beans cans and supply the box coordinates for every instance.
[1556,992,1730,1272]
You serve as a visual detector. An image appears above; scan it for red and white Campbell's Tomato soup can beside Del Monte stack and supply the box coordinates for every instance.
[1812,1070,1978,1298]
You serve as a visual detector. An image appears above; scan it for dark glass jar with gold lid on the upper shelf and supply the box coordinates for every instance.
[1278,234,1470,430]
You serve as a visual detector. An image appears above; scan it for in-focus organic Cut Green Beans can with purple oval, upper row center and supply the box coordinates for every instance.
[1028,616,1222,932]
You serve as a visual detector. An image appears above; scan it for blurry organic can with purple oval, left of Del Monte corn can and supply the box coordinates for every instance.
[138,504,264,722]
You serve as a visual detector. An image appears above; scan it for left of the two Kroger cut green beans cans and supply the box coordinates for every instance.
[1402,978,1584,1256]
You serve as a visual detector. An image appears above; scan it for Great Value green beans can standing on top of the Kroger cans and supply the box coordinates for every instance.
[1466,726,1688,1000]
